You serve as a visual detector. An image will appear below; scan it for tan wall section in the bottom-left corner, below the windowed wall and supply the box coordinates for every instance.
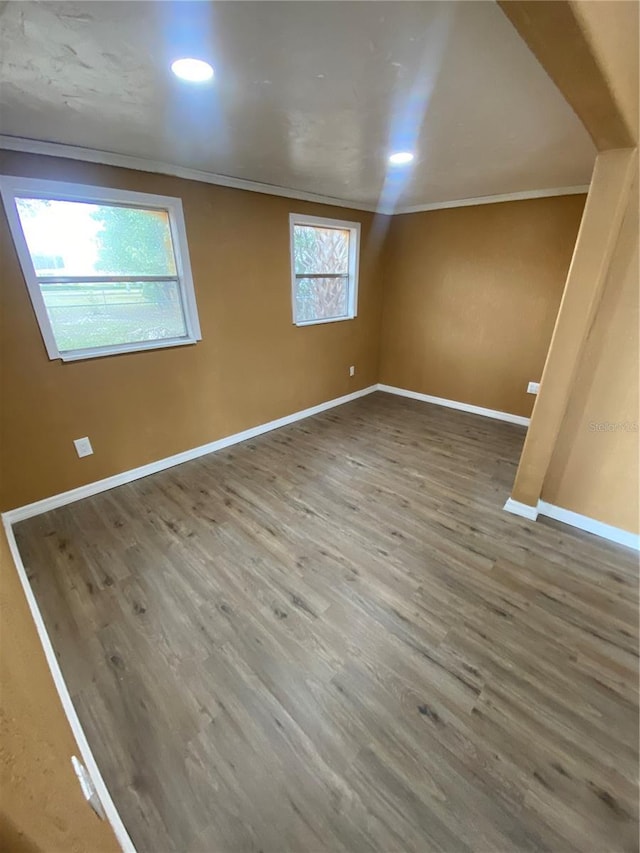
[0,530,120,853]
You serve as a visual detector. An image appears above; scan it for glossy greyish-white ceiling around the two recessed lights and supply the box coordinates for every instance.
[0,0,595,209]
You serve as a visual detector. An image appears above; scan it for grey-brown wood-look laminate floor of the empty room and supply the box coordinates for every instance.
[16,393,638,853]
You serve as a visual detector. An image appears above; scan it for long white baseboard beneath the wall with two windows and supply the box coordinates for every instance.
[2,385,377,524]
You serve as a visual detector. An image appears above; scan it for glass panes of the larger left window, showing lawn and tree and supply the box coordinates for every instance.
[16,198,187,352]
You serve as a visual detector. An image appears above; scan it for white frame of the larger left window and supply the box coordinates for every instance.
[0,175,202,362]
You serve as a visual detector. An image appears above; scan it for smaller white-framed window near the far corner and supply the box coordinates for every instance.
[289,213,360,326]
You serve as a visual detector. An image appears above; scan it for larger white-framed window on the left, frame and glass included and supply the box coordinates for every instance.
[0,176,201,361]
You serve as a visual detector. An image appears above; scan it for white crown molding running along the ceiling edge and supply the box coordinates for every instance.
[0,134,589,216]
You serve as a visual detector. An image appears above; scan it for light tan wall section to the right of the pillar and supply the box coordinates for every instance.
[542,163,640,533]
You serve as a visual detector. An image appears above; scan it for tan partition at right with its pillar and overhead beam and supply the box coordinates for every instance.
[500,0,640,532]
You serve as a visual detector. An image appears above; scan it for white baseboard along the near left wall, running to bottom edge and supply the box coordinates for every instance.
[4,521,136,853]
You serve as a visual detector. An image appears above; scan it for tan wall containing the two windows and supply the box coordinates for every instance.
[0,152,386,510]
